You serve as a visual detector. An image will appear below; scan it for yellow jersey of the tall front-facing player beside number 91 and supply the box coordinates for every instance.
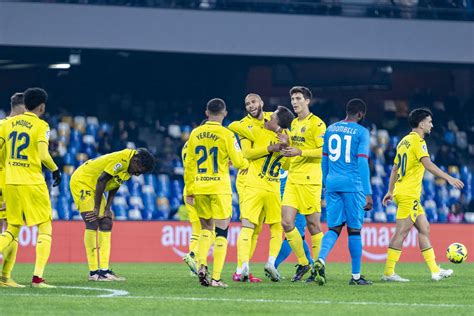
[288,113,326,185]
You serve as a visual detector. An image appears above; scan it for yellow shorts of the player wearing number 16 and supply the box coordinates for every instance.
[240,187,281,225]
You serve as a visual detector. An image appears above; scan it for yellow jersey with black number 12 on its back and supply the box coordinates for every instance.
[0,112,49,185]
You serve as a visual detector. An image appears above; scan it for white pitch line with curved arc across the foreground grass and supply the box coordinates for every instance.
[1,292,474,308]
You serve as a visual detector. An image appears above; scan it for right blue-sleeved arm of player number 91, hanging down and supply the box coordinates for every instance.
[357,128,374,211]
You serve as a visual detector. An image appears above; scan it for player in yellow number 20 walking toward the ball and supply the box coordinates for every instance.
[382,109,464,282]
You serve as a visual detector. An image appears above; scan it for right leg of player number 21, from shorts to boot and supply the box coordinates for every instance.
[211,194,232,287]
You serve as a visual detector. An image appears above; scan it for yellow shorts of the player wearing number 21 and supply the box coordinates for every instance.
[194,194,232,219]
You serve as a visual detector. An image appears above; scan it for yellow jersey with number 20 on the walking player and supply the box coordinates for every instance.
[393,132,429,198]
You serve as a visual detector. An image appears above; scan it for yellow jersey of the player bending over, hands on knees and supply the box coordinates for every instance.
[71,149,137,192]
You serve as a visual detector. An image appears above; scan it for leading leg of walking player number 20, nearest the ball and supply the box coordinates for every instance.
[415,214,453,281]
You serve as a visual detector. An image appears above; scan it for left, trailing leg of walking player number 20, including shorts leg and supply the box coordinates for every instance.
[382,197,414,282]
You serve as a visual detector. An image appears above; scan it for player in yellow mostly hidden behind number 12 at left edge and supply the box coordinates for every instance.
[0,93,26,287]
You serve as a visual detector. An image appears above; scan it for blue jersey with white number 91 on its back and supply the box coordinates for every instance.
[322,120,372,195]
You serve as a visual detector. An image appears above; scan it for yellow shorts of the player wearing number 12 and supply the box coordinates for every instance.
[4,183,53,226]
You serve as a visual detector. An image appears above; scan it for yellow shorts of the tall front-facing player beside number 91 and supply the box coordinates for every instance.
[281,183,322,215]
